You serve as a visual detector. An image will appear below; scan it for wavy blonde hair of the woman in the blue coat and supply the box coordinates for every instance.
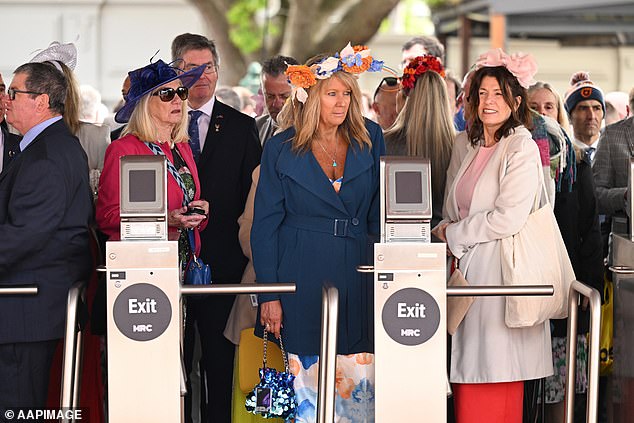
[277,71,372,152]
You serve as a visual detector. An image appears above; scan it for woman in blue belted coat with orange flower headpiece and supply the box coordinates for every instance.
[251,45,385,422]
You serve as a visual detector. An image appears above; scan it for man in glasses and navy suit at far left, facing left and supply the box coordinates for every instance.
[0,63,92,415]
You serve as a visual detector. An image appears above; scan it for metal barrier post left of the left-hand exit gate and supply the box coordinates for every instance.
[60,282,85,422]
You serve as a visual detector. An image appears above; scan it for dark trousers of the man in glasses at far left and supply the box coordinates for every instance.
[0,340,58,416]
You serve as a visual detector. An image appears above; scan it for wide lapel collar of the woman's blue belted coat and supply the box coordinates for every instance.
[277,129,373,215]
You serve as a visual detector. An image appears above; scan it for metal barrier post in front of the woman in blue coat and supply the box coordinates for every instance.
[317,285,339,423]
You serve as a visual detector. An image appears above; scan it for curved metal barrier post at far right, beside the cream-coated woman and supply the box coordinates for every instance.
[565,281,601,423]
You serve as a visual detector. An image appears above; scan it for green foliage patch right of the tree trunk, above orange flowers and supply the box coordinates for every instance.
[227,0,266,54]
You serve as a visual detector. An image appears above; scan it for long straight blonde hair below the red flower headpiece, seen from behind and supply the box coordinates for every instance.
[385,71,456,203]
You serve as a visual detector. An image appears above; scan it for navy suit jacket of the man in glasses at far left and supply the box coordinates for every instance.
[0,120,93,344]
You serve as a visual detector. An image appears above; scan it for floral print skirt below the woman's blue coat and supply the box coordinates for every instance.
[288,353,374,423]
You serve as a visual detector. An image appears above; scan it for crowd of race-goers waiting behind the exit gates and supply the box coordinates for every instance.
[0,33,634,423]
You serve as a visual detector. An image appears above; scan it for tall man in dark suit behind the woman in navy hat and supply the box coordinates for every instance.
[172,34,261,423]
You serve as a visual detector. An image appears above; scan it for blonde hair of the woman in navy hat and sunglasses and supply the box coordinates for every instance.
[121,87,189,143]
